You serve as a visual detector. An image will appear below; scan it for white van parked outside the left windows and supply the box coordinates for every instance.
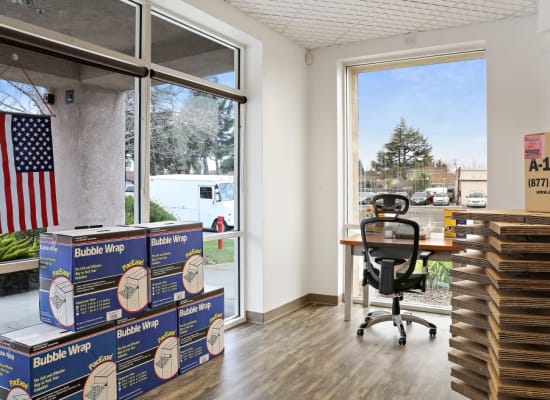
[149,174,235,231]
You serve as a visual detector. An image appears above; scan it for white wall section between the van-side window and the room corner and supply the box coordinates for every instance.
[157,0,310,313]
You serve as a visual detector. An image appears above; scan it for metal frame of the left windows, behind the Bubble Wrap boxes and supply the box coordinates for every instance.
[0,0,246,327]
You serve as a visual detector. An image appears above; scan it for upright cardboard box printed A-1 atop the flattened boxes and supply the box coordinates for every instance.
[523,132,550,212]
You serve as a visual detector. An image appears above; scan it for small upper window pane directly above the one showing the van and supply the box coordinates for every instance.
[151,15,238,88]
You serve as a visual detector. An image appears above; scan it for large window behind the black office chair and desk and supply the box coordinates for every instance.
[347,51,486,309]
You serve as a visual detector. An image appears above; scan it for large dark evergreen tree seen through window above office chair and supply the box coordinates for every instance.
[371,117,433,179]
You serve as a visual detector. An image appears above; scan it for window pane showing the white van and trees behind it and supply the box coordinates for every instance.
[149,82,238,230]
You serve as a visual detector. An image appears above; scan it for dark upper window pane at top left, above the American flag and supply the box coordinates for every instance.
[0,0,139,56]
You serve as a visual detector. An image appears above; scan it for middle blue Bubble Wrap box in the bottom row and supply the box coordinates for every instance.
[116,304,179,400]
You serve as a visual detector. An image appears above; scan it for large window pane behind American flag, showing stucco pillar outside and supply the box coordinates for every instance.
[0,44,135,304]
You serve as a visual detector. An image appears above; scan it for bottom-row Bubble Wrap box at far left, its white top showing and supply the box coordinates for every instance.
[0,324,117,400]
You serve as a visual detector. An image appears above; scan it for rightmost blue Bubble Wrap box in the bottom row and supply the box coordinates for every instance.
[178,288,224,374]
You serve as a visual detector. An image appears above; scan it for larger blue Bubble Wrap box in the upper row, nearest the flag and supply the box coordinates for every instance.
[39,227,149,331]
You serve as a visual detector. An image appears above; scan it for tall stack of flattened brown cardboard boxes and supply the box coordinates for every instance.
[449,210,550,400]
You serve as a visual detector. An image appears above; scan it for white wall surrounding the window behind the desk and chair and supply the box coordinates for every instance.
[309,17,550,295]
